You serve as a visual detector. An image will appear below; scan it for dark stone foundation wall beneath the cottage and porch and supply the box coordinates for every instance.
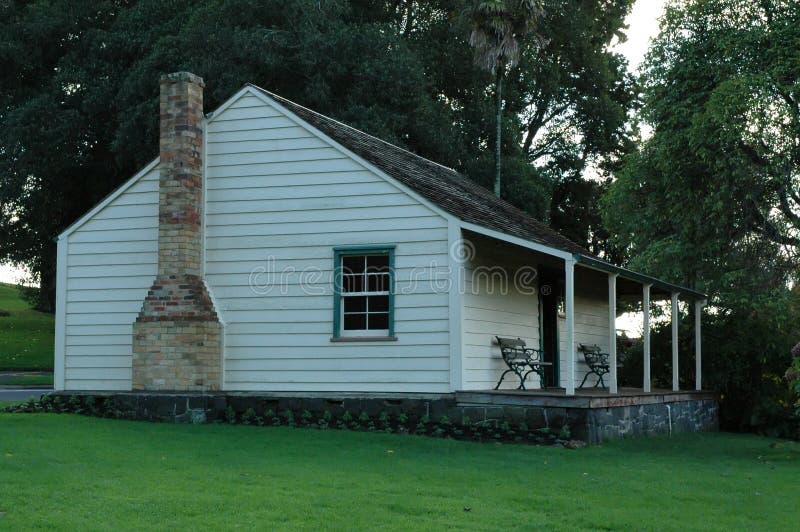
[50,393,719,444]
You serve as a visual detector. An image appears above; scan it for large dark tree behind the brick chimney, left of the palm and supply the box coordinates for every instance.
[0,0,438,310]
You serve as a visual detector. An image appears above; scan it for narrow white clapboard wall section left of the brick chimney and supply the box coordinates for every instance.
[59,164,158,390]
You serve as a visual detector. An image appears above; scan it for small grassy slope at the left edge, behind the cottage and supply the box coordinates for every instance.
[0,283,54,370]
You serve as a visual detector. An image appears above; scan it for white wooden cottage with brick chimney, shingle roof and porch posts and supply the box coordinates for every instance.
[55,73,704,395]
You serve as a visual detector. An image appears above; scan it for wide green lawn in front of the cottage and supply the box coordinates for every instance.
[0,414,800,530]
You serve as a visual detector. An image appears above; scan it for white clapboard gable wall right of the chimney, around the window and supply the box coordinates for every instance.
[206,93,450,392]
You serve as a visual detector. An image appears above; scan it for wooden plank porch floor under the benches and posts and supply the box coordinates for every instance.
[456,387,716,408]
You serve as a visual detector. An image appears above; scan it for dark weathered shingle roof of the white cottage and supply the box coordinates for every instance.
[252,85,591,256]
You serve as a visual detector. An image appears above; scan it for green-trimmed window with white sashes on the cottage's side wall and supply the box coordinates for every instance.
[333,246,394,337]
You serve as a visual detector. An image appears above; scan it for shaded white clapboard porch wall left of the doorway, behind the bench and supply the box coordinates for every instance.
[461,242,539,390]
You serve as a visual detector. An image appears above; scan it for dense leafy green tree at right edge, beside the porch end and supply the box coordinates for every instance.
[604,0,800,433]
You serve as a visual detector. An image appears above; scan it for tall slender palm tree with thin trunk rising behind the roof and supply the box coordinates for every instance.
[468,0,543,197]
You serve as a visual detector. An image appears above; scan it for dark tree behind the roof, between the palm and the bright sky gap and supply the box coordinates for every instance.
[460,0,636,251]
